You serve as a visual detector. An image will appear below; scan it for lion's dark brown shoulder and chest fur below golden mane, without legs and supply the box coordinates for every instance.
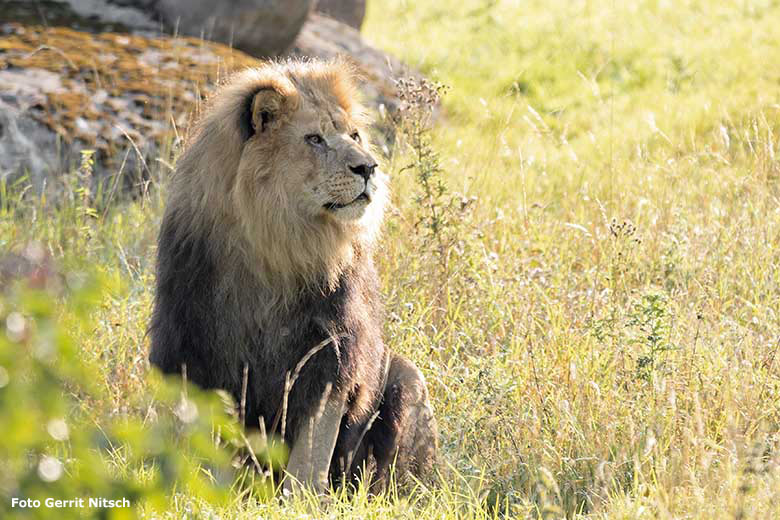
[150,205,384,441]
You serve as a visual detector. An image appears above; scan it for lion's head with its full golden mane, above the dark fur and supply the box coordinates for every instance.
[171,60,387,289]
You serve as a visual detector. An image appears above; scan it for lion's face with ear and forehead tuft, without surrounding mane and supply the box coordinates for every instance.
[234,63,383,225]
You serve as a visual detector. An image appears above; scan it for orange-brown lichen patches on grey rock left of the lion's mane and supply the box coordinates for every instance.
[0,24,258,187]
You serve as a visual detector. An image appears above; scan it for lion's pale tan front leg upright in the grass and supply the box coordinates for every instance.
[284,395,347,493]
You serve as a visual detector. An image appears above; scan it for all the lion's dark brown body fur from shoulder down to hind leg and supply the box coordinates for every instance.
[149,65,436,486]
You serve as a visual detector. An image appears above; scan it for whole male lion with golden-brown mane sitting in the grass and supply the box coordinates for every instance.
[149,60,437,492]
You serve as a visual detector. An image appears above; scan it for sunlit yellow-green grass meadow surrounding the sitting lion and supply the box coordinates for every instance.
[0,0,780,519]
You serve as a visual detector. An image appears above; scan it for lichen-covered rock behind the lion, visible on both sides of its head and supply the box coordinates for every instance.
[0,18,412,187]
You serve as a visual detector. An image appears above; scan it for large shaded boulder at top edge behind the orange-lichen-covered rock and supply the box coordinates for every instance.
[0,0,314,57]
